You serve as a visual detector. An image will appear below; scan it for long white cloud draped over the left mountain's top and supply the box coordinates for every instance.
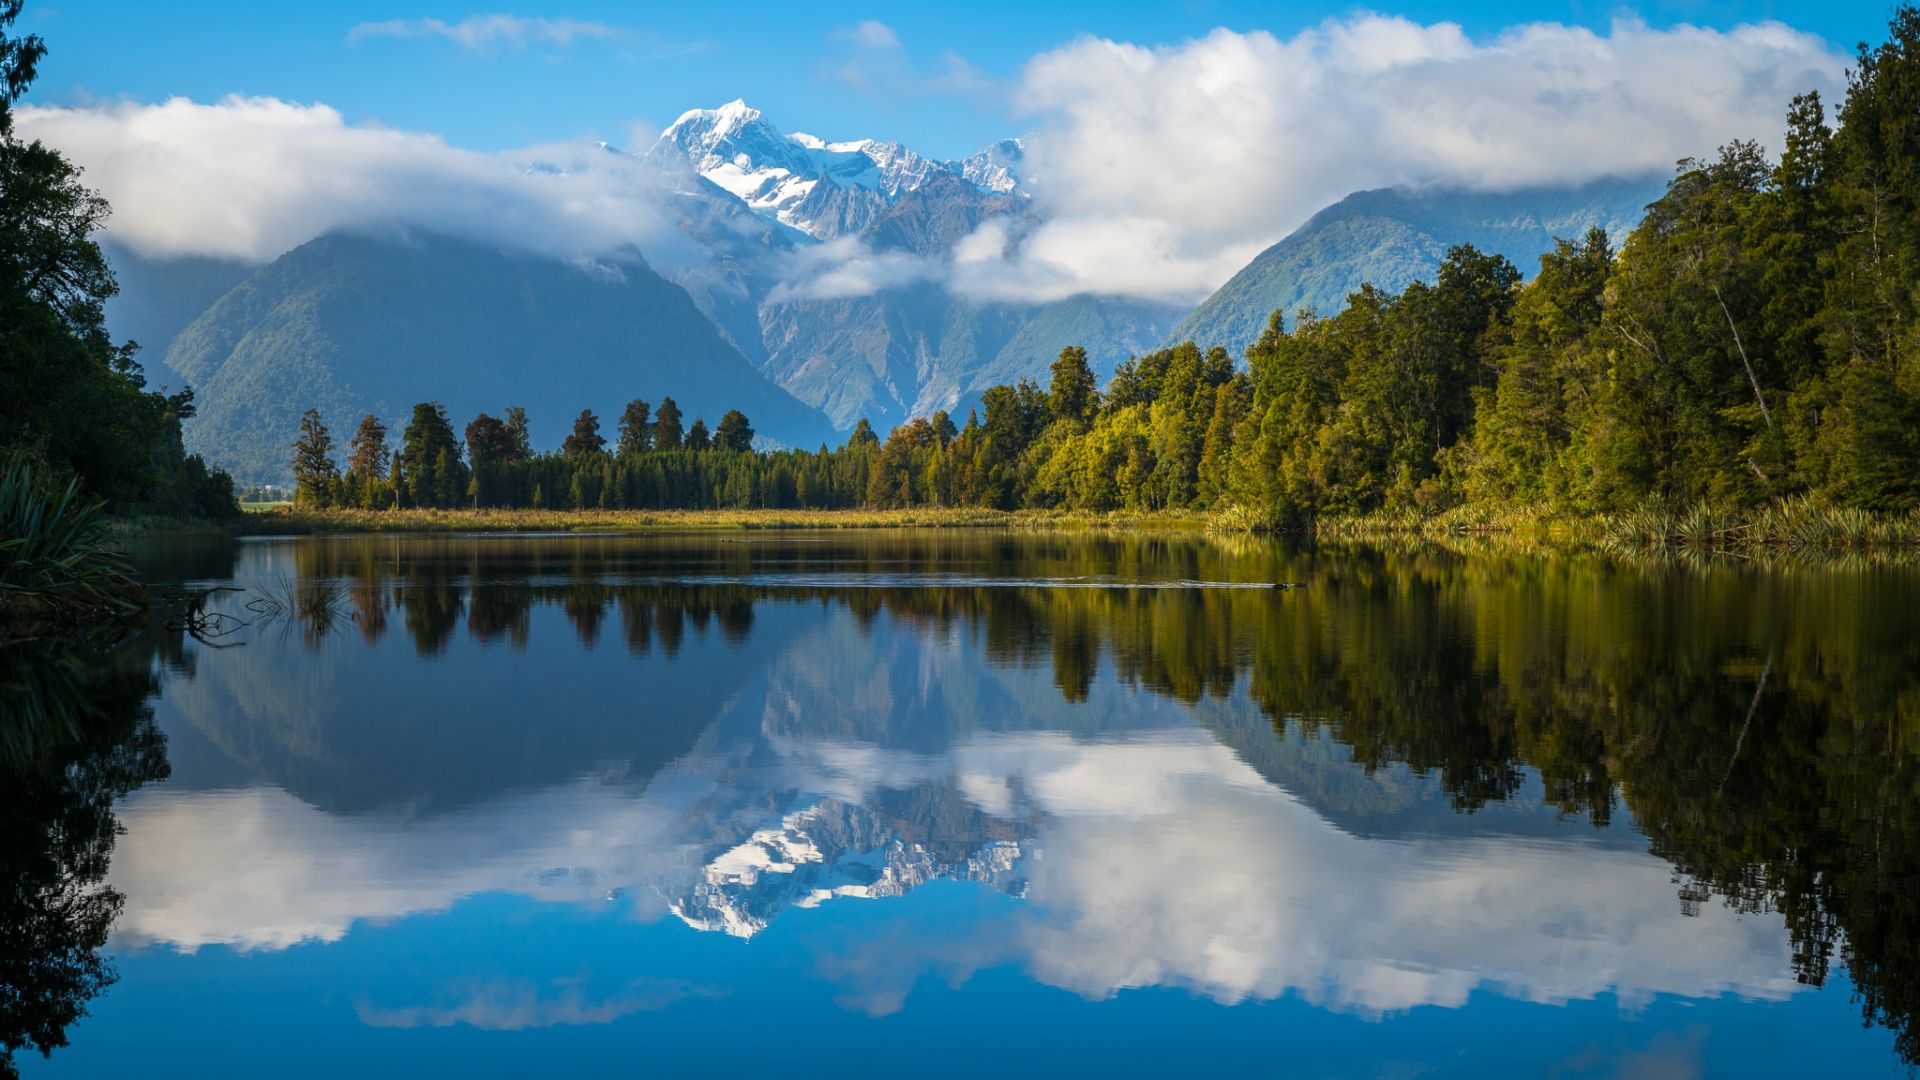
[17,98,672,261]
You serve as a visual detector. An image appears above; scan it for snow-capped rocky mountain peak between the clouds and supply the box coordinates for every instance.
[647,100,1025,240]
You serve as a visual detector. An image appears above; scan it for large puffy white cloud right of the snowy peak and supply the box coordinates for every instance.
[958,15,1847,300]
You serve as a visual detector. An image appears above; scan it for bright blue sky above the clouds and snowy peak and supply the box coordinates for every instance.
[23,0,1891,156]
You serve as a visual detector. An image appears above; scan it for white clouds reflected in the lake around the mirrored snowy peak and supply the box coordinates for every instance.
[111,722,1797,1006]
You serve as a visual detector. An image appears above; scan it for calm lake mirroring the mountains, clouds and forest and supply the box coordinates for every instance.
[11,532,1920,1076]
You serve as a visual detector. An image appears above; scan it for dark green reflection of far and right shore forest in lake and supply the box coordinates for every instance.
[274,536,1920,1061]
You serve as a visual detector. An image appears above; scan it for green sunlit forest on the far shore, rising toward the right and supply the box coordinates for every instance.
[294,6,1920,527]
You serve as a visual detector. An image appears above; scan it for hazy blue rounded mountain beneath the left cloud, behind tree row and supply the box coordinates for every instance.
[165,233,831,482]
